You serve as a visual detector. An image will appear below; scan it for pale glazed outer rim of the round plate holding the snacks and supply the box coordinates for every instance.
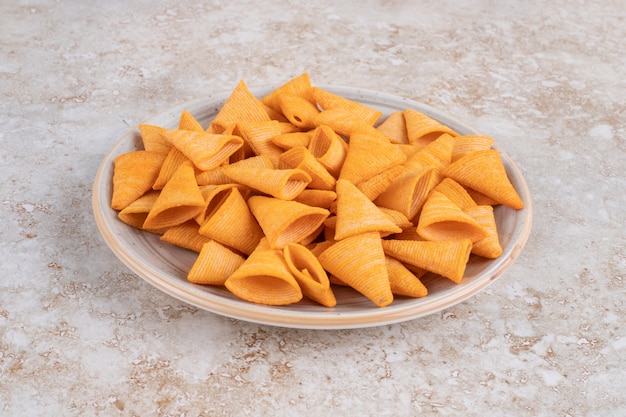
[92,85,533,330]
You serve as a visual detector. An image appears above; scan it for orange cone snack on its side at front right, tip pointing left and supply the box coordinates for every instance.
[382,239,472,284]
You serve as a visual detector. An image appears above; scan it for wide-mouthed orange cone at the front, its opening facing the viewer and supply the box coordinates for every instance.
[224,237,303,305]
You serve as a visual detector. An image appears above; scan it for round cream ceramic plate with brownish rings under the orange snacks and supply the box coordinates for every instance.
[93,86,532,329]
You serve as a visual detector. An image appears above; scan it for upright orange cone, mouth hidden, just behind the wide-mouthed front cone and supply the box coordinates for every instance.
[200,187,263,254]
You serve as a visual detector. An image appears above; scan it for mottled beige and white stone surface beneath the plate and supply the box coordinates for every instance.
[0,0,626,417]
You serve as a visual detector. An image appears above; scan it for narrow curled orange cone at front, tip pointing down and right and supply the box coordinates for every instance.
[283,243,337,307]
